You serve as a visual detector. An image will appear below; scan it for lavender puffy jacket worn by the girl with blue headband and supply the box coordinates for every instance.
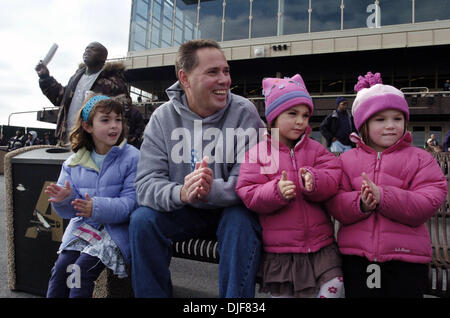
[52,140,139,262]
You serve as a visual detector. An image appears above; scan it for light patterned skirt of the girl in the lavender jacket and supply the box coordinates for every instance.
[64,228,128,278]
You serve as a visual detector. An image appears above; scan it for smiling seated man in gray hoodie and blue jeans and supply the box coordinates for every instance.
[130,40,264,297]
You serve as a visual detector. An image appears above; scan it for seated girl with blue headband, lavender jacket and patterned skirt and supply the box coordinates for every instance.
[46,95,139,298]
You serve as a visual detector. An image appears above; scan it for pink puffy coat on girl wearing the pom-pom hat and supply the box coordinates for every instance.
[326,132,447,263]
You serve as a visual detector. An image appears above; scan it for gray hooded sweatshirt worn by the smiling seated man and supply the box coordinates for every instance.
[135,82,265,211]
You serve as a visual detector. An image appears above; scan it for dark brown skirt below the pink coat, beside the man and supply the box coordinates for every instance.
[256,244,342,298]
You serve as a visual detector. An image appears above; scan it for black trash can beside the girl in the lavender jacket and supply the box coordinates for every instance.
[5,147,72,296]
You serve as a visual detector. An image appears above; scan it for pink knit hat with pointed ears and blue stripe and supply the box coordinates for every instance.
[262,74,314,124]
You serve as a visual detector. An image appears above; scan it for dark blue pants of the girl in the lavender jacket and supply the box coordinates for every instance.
[47,251,105,298]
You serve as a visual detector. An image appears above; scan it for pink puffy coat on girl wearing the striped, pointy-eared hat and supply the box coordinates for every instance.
[236,129,342,253]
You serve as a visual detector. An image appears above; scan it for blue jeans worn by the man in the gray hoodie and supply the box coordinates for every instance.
[130,205,261,297]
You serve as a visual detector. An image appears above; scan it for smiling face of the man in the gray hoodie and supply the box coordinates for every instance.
[180,48,231,117]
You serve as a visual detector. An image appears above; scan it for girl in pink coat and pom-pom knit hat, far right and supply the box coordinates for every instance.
[326,72,447,297]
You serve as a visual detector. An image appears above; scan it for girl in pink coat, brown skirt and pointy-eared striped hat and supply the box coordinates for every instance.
[236,74,343,298]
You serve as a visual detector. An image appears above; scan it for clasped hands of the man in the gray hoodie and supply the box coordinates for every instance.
[180,156,213,203]
